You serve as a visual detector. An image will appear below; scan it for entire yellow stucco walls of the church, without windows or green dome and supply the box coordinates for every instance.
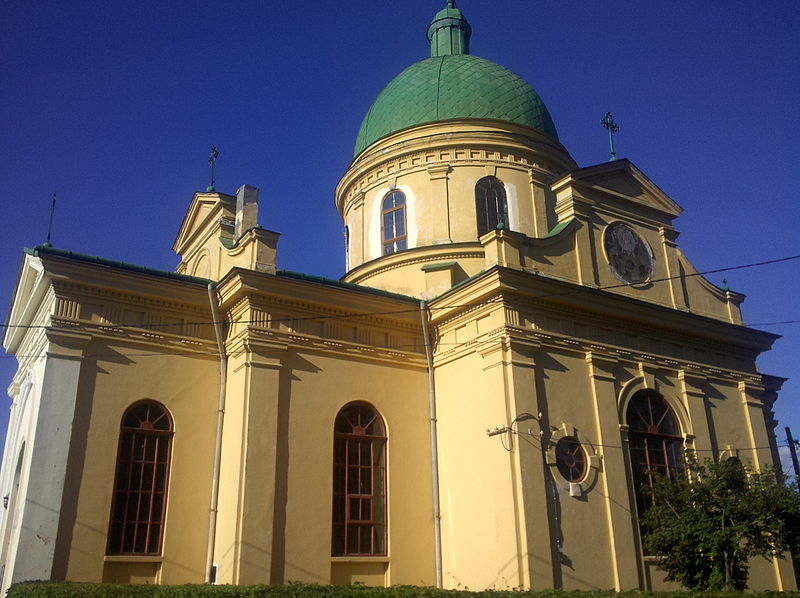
[1,105,795,590]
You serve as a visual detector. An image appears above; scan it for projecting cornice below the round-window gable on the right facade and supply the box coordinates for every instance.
[424,268,772,375]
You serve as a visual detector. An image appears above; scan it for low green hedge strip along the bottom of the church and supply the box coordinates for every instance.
[7,582,800,598]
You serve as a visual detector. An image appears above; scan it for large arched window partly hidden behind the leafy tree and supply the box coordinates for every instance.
[625,390,684,515]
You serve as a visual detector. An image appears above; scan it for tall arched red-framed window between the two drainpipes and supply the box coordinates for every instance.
[332,403,386,556]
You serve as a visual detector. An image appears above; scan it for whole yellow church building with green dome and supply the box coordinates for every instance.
[0,0,797,591]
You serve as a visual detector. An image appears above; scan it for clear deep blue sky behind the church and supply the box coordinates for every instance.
[0,0,800,474]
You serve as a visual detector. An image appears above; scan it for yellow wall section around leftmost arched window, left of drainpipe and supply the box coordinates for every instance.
[67,342,216,583]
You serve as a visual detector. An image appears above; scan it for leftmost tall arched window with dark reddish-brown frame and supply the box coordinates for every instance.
[108,401,172,554]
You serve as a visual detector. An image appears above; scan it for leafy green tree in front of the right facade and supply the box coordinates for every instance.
[642,455,800,590]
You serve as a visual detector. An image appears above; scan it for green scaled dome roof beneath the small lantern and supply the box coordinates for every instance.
[355,54,558,156]
